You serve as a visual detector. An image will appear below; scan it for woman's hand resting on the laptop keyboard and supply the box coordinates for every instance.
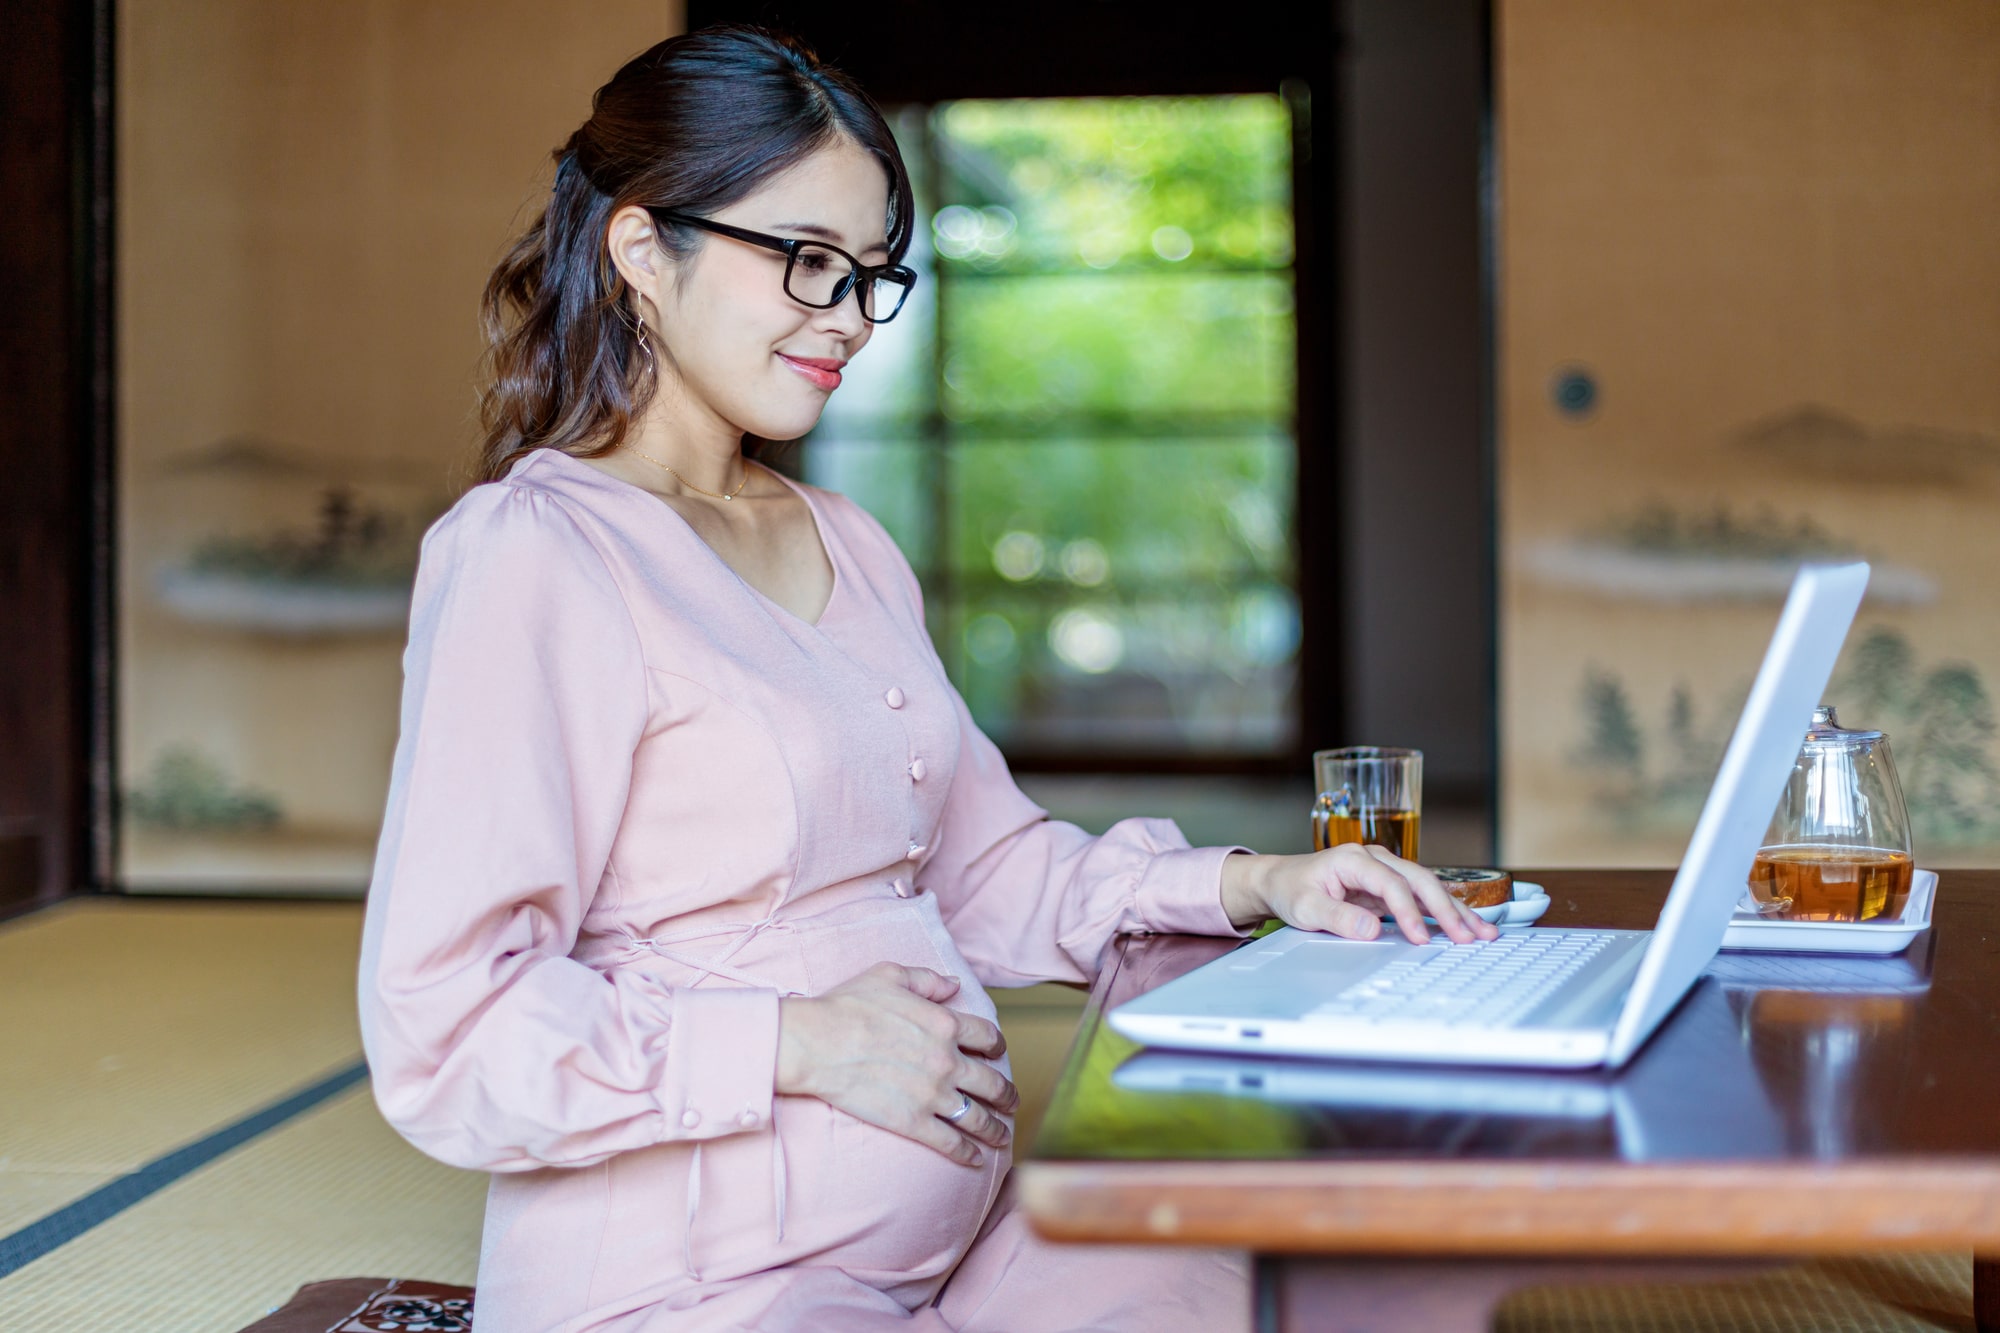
[1222,843,1500,945]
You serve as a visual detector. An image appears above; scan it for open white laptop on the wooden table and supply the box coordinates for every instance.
[1108,564,1868,1069]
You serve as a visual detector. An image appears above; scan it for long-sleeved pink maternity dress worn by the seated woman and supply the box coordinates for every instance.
[360,450,1250,1333]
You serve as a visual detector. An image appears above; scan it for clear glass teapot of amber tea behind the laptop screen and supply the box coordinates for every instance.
[1744,705,1914,921]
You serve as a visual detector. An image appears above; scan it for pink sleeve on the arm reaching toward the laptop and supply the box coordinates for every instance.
[846,492,1248,987]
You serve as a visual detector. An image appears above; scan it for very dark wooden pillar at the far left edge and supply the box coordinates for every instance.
[0,0,110,913]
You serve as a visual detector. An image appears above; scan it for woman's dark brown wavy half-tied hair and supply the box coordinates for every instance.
[478,26,914,480]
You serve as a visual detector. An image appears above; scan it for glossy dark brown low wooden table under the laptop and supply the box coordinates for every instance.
[1018,871,2000,1333]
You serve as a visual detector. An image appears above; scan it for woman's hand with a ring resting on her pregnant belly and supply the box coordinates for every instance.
[776,963,1020,1167]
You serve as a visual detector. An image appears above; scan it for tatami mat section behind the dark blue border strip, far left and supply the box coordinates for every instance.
[0,899,362,1168]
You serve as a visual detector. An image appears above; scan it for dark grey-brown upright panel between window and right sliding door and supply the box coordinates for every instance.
[1322,0,1498,805]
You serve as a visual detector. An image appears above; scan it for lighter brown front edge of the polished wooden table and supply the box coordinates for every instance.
[1016,1157,2000,1255]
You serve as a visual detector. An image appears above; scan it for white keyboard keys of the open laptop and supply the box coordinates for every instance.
[1306,931,1618,1027]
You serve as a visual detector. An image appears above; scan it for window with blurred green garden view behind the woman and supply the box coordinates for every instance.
[804,96,1302,767]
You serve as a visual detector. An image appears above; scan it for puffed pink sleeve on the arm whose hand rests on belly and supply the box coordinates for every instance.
[360,482,778,1171]
